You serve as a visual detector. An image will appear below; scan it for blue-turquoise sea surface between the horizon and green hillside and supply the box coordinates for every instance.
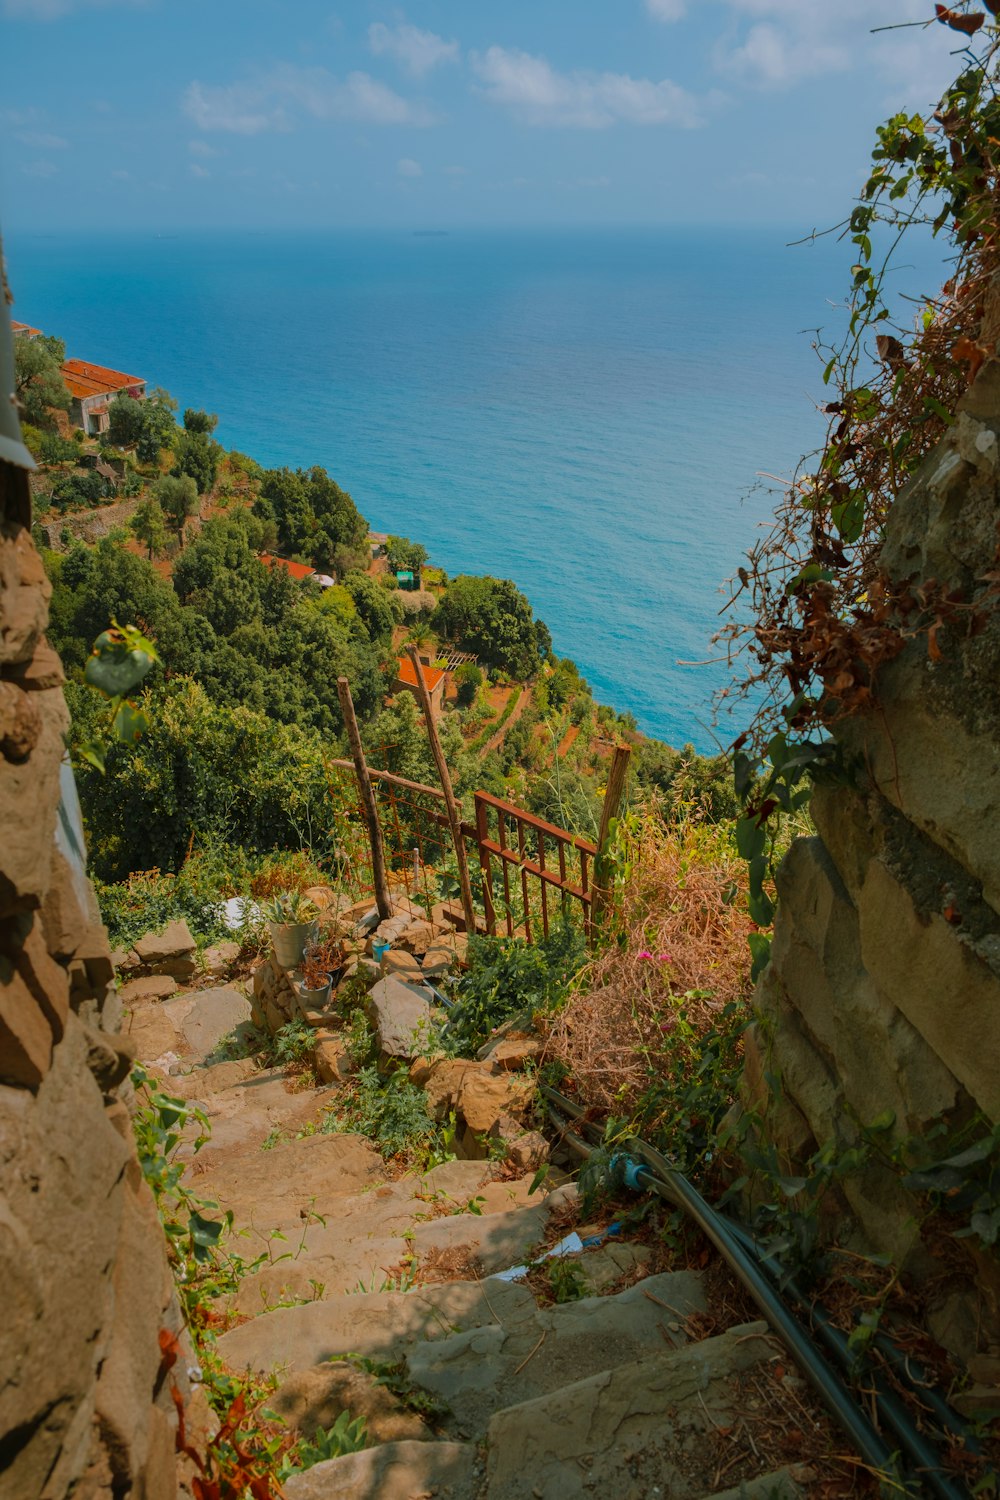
[6,228,934,750]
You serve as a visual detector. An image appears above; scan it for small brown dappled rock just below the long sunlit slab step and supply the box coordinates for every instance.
[267,1361,427,1443]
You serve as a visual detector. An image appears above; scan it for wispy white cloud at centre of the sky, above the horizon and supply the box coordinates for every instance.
[472,47,702,129]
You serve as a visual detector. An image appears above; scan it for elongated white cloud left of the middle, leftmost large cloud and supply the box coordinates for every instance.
[181,63,433,135]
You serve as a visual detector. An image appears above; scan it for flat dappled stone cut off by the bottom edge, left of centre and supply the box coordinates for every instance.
[283,1442,477,1500]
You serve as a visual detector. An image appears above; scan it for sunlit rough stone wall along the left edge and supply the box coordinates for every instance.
[0,447,180,1500]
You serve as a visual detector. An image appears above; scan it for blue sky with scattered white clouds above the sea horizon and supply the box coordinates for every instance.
[0,0,960,233]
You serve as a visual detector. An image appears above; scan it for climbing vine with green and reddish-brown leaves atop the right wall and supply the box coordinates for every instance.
[720,0,1000,975]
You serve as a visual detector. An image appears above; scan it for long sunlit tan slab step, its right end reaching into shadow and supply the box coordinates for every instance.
[219,1281,535,1374]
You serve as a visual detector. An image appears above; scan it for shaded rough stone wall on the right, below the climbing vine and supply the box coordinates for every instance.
[745,359,1000,1361]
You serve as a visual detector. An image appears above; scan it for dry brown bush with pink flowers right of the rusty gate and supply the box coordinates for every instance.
[546,815,753,1113]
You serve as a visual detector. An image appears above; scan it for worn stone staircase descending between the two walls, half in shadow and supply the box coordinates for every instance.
[124,942,807,1500]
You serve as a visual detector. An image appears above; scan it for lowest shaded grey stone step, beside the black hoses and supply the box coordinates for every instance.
[483,1323,780,1500]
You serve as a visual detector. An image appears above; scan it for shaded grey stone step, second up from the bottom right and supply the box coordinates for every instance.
[406,1271,705,1439]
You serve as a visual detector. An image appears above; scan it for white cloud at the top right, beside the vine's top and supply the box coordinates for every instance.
[715,0,955,104]
